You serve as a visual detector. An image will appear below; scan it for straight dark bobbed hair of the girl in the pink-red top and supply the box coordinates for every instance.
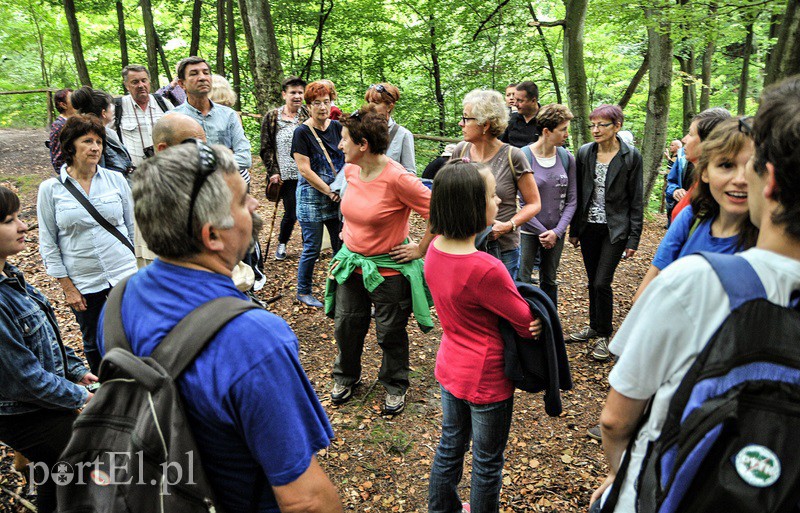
[430,160,486,239]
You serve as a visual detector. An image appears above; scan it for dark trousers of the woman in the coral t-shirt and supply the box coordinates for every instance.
[333,273,411,395]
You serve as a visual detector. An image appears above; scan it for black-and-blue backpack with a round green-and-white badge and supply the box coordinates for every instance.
[604,253,800,513]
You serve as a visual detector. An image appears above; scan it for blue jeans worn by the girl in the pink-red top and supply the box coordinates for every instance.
[428,387,514,513]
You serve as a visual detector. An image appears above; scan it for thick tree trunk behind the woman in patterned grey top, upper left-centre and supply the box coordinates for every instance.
[239,0,283,113]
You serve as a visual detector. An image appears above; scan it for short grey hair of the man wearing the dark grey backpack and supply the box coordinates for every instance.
[132,144,239,260]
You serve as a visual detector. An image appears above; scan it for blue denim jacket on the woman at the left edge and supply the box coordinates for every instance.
[0,263,89,415]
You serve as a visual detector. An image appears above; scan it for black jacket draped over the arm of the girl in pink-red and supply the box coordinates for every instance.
[500,282,572,417]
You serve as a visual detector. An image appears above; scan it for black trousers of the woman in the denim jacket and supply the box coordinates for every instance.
[0,410,78,513]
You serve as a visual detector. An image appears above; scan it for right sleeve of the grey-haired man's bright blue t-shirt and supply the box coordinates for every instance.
[226,314,333,486]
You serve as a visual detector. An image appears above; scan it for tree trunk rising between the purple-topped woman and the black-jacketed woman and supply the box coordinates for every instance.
[564,0,591,151]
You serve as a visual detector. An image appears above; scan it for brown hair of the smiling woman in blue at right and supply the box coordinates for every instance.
[691,118,758,250]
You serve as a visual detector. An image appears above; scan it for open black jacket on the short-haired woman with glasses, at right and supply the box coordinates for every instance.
[569,136,644,249]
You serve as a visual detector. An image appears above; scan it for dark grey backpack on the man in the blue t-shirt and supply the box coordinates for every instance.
[57,279,258,513]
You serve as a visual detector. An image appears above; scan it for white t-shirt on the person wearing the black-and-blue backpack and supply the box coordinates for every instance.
[604,248,800,512]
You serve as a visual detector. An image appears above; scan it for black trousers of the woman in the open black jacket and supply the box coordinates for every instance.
[580,223,628,337]
